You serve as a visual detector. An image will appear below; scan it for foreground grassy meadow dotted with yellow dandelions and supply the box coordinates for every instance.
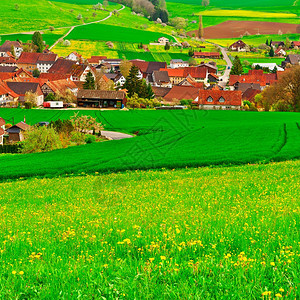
[0,162,300,299]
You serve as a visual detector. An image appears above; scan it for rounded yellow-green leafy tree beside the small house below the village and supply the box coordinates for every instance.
[21,126,62,153]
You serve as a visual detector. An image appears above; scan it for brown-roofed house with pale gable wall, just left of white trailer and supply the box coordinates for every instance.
[6,81,44,106]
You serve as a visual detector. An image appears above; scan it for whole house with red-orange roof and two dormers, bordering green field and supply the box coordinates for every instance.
[193,89,242,110]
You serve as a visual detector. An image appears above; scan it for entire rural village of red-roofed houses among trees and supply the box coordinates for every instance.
[0,32,300,145]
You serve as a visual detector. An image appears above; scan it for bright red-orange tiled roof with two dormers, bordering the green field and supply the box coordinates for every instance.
[194,90,242,106]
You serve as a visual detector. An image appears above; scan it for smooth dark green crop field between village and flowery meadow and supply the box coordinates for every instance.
[0,108,300,179]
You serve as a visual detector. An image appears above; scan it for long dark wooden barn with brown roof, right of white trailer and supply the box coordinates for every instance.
[77,90,126,108]
